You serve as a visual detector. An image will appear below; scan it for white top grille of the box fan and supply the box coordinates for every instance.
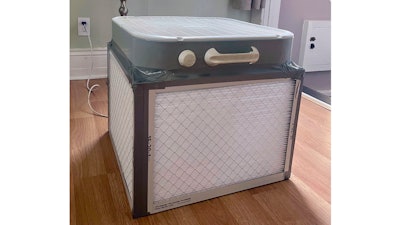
[113,16,293,42]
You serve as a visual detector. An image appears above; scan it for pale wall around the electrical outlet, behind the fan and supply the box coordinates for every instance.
[70,0,251,49]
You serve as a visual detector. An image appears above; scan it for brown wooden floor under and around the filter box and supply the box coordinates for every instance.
[70,79,331,225]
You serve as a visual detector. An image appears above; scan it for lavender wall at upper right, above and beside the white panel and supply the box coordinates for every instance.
[278,0,331,63]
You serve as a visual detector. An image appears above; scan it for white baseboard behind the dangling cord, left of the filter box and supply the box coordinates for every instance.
[70,48,107,80]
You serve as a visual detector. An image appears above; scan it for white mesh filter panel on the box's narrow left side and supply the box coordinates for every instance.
[108,52,134,200]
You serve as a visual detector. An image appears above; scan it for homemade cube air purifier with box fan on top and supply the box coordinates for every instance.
[108,17,304,217]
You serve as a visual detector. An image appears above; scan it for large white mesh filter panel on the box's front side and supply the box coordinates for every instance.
[153,80,295,202]
